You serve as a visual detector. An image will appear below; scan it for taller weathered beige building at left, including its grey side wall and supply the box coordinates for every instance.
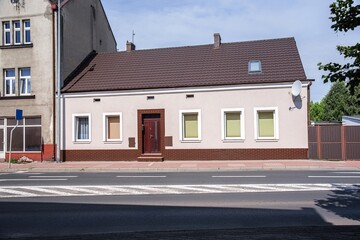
[0,0,116,160]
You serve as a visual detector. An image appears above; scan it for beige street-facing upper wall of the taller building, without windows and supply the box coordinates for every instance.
[0,0,54,146]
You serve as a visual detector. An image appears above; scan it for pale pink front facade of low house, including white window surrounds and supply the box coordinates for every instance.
[62,82,309,160]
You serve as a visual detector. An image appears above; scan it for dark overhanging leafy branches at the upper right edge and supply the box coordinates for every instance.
[318,0,360,94]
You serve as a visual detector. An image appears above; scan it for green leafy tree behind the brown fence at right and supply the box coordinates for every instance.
[322,81,356,121]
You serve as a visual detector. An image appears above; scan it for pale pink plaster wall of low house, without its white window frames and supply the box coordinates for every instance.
[63,84,308,153]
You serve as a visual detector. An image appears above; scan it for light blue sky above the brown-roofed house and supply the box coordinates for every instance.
[102,0,360,101]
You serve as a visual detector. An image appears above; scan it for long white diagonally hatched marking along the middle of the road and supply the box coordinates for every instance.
[0,183,360,198]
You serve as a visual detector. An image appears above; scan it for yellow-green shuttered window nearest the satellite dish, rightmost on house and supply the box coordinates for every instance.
[258,111,275,138]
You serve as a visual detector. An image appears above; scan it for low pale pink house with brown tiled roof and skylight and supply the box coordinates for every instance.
[61,34,311,161]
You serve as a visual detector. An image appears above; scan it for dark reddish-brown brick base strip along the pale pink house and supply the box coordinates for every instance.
[62,148,308,161]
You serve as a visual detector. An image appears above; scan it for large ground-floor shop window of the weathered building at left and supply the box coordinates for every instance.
[7,117,42,152]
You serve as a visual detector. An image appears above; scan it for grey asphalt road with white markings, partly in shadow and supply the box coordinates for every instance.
[0,171,360,239]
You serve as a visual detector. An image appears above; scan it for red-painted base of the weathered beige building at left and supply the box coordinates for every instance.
[5,144,56,161]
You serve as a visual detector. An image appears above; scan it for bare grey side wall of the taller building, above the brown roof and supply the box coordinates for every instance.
[62,0,116,82]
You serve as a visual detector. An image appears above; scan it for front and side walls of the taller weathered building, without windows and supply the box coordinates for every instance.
[0,0,116,159]
